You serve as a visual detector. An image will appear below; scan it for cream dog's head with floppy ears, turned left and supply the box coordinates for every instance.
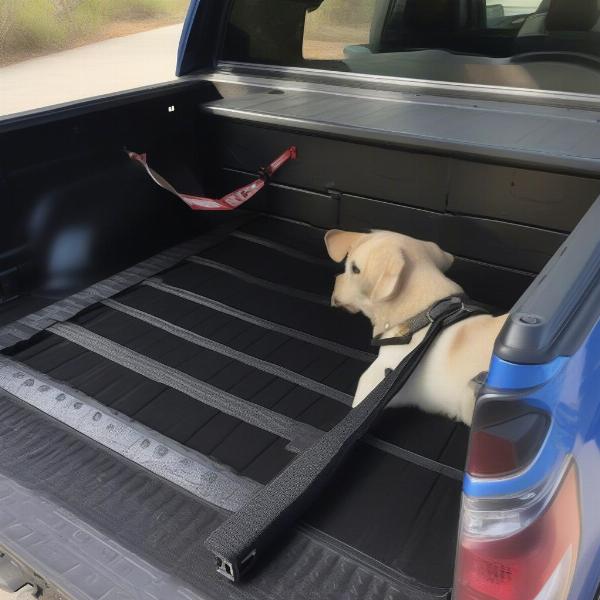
[325,229,454,317]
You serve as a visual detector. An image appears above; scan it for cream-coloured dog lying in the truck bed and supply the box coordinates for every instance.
[325,229,507,426]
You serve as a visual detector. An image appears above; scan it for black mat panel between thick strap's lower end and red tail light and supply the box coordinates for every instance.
[306,446,462,587]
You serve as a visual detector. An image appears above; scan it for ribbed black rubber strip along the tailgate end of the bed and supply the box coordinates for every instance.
[0,395,447,600]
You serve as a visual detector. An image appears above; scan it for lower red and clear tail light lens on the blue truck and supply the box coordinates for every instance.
[453,460,580,600]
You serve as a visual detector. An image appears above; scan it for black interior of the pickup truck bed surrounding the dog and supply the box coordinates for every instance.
[0,59,600,600]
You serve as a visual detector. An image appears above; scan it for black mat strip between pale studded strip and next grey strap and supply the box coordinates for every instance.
[10,335,293,483]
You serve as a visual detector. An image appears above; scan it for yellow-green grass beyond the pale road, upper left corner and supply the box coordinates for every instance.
[0,0,189,62]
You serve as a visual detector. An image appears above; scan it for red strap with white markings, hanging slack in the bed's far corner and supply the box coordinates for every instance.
[127,146,297,210]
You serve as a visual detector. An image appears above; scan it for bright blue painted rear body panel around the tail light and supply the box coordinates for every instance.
[464,316,600,600]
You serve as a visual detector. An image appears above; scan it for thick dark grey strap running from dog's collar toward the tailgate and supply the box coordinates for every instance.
[205,296,487,582]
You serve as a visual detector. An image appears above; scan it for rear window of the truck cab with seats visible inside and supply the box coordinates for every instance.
[222,0,600,94]
